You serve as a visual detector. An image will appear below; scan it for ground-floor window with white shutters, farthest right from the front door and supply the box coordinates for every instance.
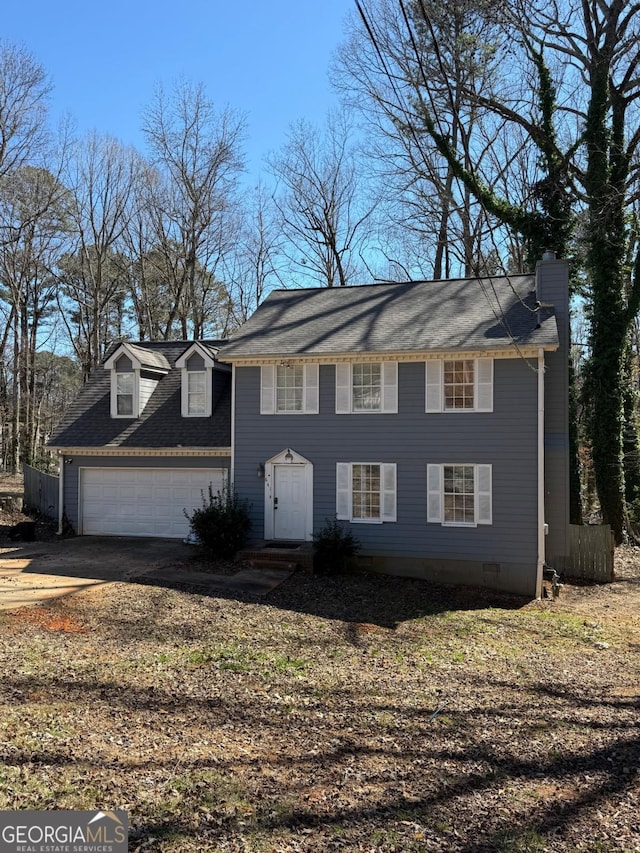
[427,464,492,527]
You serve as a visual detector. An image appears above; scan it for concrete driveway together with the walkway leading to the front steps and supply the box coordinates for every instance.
[0,536,291,610]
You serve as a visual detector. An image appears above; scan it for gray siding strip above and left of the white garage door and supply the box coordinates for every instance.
[62,454,231,531]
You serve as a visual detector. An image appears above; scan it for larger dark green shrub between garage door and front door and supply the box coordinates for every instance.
[185,486,251,560]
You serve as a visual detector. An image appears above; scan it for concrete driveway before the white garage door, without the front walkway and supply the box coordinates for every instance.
[0,536,193,610]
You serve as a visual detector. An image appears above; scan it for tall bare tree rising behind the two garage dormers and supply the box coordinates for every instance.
[143,83,244,338]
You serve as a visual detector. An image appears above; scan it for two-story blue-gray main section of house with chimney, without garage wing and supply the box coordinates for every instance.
[221,253,568,595]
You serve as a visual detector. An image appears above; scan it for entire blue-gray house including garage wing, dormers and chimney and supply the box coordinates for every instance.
[50,253,569,595]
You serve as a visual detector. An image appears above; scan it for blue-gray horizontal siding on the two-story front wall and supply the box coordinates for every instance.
[234,358,537,571]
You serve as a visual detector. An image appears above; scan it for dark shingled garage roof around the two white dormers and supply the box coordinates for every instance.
[49,341,231,448]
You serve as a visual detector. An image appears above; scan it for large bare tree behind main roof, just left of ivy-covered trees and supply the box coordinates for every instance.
[334,0,522,278]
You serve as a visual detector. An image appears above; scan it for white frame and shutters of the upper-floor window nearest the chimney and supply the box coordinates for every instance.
[425,356,493,413]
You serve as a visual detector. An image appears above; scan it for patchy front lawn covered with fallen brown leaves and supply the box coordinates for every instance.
[0,564,640,853]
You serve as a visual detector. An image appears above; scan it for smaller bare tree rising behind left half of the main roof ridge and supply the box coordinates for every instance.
[269,112,375,287]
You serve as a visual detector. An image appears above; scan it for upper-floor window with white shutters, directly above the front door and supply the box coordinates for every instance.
[260,363,319,415]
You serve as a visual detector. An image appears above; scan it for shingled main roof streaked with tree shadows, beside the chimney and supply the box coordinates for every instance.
[220,275,558,360]
